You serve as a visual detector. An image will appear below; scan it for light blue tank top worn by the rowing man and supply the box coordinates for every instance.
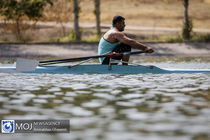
[98,37,120,64]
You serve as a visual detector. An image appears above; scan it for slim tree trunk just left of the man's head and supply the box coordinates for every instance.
[94,0,101,37]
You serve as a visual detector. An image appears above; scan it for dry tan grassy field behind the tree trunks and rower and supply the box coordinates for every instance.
[0,0,210,42]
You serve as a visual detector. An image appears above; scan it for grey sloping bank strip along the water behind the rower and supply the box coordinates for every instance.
[0,42,210,58]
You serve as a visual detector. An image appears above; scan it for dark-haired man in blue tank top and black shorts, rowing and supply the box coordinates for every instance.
[98,16,153,65]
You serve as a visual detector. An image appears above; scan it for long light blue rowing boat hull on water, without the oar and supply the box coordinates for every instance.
[0,64,210,74]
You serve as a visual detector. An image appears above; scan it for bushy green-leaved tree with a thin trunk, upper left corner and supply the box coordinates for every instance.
[0,0,52,40]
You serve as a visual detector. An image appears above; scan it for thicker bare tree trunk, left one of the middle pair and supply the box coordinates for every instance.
[73,0,81,41]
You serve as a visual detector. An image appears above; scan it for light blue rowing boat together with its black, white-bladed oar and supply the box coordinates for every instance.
[0,51,210,74]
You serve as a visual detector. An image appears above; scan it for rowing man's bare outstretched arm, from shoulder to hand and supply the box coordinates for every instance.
[115,33,153,53]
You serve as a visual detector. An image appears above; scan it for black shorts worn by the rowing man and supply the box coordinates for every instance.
[102,43,131,65]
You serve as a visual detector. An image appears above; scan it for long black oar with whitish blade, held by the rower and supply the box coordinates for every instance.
[16,51,145,72]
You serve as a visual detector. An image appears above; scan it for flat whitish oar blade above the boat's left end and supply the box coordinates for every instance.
[16,58,39,72]
